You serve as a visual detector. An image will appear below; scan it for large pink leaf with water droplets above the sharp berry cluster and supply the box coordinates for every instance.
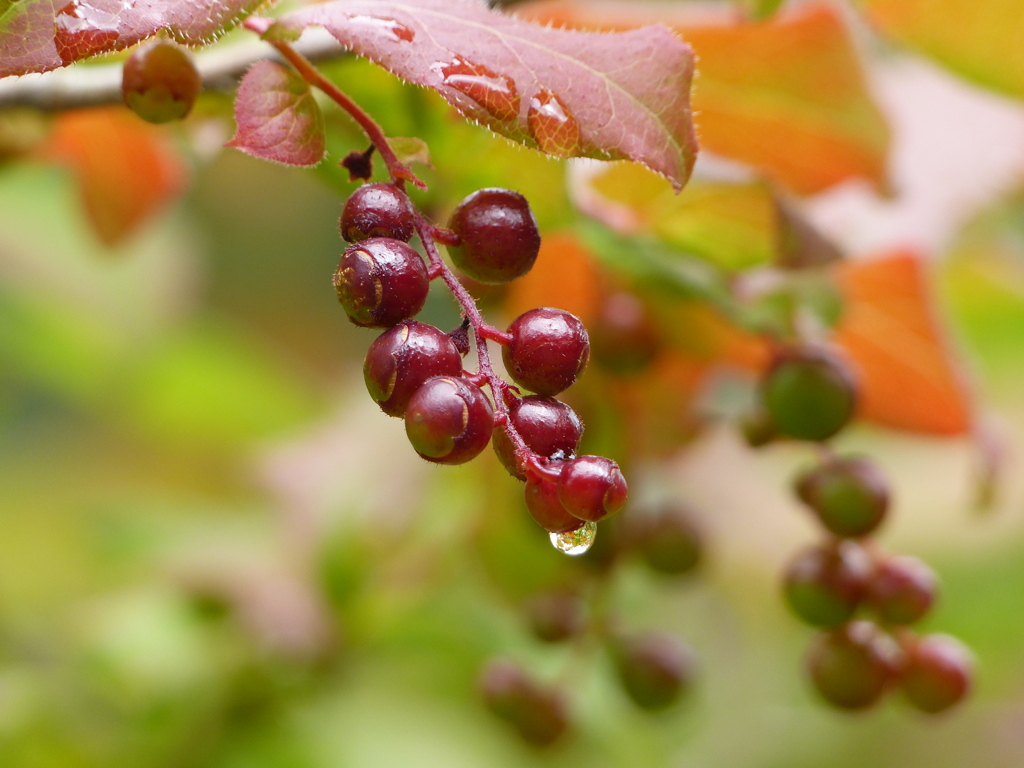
[267,0,696,189]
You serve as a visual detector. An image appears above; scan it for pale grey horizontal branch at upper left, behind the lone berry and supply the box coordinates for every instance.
[0,29,347,112]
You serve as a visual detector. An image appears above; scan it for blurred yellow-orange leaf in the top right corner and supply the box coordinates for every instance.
[864,0,1024,98]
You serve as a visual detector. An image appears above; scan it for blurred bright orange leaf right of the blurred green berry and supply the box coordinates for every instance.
[836,251,974,435]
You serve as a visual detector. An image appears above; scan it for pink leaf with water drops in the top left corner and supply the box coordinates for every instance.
[0,0,262,77]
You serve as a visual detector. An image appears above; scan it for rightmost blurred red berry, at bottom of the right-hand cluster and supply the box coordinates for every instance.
[900,635,974,715]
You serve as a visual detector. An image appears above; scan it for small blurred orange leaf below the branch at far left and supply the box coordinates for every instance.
[43,106,185,246]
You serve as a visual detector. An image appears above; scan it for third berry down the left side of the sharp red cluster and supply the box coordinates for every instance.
[362,321,462,417]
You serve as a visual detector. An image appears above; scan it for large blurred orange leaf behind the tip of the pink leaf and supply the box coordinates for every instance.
[520,0,895,195]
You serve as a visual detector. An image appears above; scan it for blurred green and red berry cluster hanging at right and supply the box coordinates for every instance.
[749,348,972,713]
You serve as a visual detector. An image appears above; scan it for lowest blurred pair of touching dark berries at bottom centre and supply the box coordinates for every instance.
[480,660,569,746]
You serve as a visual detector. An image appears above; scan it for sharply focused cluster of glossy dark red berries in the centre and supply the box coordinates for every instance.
[334,183,627,534]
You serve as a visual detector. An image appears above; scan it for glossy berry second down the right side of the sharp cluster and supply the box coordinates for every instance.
[502,307,590,395]
